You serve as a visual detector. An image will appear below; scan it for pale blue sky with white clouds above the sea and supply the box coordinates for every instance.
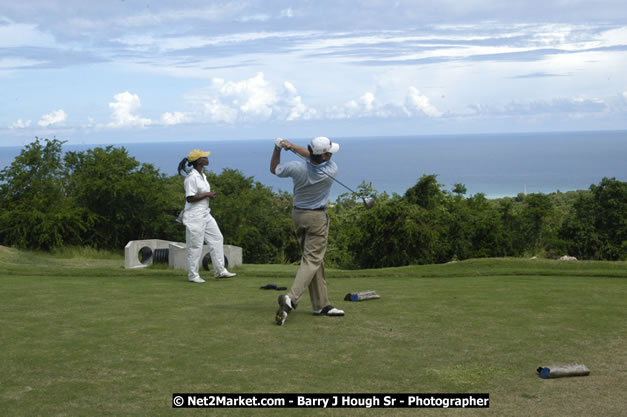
[0,0,627,146]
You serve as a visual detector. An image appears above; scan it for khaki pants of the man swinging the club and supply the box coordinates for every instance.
[289,209,329,311]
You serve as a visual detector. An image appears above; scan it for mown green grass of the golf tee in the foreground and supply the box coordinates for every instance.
[0,248,627,416]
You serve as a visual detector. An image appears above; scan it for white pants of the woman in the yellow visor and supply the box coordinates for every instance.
[183,212,226,280]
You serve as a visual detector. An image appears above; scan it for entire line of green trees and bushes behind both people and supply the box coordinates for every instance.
[0,138,627,268]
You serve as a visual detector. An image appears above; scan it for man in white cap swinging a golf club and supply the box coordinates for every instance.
[270,137,344,326]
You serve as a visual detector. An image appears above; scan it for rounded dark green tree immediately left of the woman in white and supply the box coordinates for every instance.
[64,146,177,249]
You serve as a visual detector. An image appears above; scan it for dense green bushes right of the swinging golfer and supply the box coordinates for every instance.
[329,175,627,268]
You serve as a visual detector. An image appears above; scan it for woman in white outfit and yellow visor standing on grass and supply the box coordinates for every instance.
[178,149,237,284]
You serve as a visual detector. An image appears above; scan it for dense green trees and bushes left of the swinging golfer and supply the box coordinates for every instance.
[0,139,298,263]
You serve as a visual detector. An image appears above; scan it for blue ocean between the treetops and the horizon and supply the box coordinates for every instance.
[0,131,627,199]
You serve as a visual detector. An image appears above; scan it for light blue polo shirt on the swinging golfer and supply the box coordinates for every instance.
[274,161,337,209]
